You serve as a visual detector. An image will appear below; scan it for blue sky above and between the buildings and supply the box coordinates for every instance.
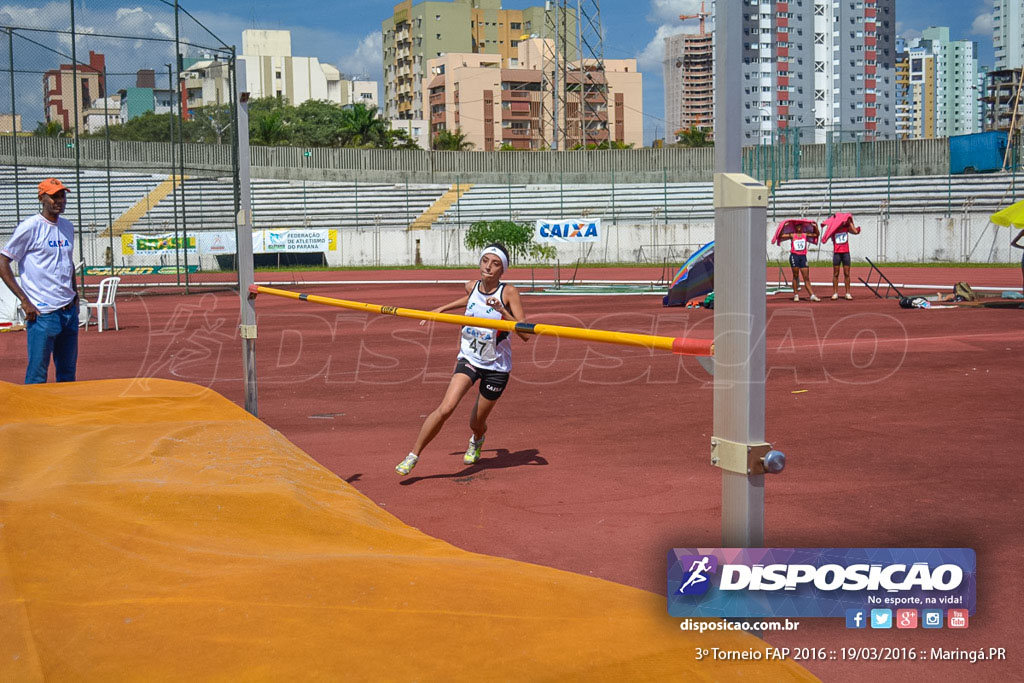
[0,0,992,143]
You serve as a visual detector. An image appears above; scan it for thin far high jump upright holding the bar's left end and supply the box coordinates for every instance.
[232,55,259,417]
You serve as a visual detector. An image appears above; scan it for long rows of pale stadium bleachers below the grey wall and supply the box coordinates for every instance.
[0,166,1024,232]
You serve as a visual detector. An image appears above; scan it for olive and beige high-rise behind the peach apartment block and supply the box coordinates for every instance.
[381,0,578,119]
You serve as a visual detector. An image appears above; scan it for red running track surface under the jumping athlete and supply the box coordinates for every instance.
[0,268,1024,680]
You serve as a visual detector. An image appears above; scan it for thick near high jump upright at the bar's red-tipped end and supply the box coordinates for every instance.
[711,2,784,548]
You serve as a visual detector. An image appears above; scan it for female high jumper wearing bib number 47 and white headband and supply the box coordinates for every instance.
[394,244,529,475]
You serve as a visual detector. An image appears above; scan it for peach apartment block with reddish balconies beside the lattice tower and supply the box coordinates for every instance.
[422,39,643,152]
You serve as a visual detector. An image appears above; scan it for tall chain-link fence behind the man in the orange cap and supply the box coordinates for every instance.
[0,0,238,285]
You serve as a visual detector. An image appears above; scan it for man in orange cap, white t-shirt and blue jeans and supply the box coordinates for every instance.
[0,178,78,384]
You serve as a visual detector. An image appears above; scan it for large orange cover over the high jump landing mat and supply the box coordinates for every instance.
[0,380,813,681]
